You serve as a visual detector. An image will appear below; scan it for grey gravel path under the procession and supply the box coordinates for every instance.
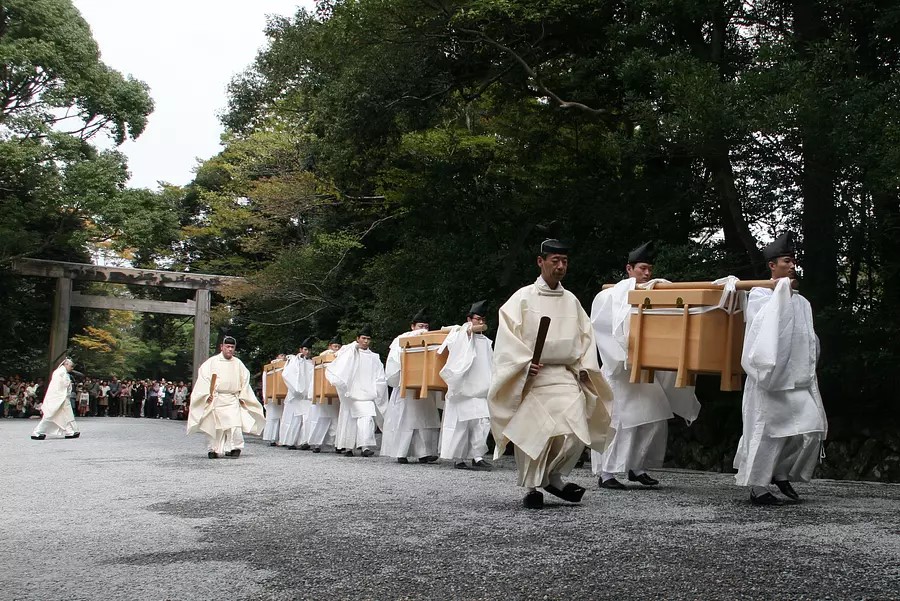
[0,418,900,600]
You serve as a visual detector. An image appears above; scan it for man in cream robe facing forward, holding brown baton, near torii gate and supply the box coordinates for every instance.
[187,336,266,459]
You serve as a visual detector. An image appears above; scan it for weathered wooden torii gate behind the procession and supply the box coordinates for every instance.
[12,259,246,381]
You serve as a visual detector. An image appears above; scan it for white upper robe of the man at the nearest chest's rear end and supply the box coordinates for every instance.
[591,278,700,430]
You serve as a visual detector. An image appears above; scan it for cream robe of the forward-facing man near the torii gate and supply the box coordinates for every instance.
[187,353,266,437]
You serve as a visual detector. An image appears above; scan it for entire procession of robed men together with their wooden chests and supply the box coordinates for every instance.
[74,232,828,509]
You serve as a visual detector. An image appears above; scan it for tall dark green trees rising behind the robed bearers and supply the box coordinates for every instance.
[186,0,900,426]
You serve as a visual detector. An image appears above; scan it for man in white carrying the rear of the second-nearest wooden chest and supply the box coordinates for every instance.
[381,309,441,463]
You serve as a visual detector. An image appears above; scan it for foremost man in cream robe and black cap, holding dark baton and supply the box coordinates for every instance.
[488,240,612,509]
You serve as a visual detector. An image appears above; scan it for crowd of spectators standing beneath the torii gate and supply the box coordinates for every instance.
[0,376,190,419]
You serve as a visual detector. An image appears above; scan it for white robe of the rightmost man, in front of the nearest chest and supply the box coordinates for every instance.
[734,278,828,486]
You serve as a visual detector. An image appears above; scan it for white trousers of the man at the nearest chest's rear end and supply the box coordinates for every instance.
[591,420,669,474]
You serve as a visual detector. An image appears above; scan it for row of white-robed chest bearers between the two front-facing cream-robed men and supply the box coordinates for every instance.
[263,310,492,470]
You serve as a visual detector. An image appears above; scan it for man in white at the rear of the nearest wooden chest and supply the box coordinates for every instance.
[591,241,700,490]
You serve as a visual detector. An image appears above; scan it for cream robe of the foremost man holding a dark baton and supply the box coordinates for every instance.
[488,278,612,459]
